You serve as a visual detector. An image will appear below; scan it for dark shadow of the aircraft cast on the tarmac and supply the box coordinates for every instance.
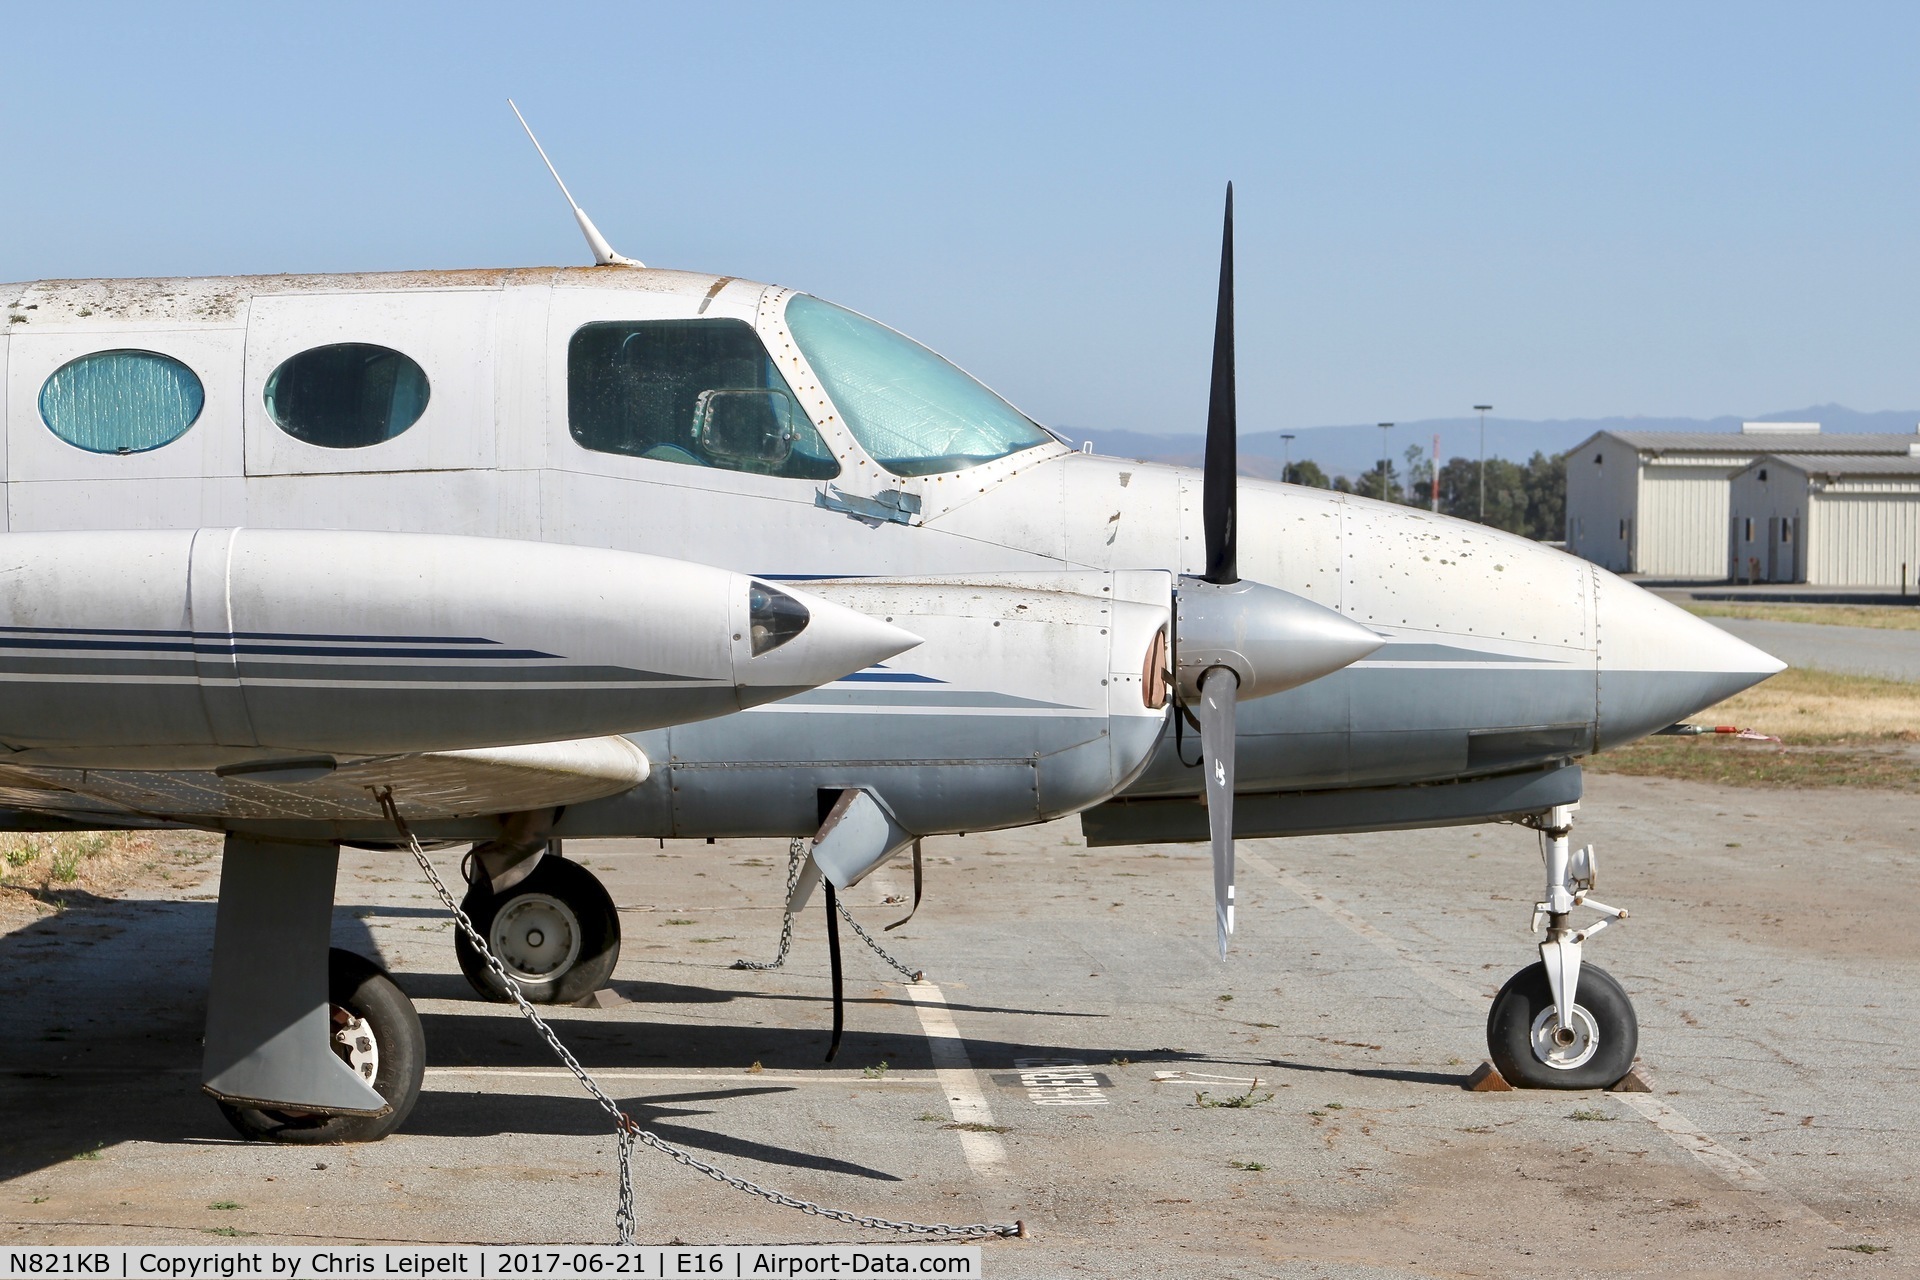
[0,894,1413,1180]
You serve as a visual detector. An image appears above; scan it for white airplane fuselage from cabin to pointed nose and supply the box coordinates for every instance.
[0,267,1778,835]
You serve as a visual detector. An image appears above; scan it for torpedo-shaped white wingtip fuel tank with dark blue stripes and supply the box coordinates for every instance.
[0,530,920,768]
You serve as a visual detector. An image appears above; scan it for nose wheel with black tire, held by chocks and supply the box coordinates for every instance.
[1486,963,1640,1088]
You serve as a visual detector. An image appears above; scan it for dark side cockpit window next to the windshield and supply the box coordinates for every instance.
[566,319,839,480]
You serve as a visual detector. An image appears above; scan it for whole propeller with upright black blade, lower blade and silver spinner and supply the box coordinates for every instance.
[1175,182,1384,960]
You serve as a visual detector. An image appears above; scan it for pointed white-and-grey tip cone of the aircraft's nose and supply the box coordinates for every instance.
[1594,574,1788,750]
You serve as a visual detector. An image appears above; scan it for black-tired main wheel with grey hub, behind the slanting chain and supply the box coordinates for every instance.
[453,856,620,1004]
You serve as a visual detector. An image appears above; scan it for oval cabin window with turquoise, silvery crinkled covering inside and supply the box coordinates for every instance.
[40,351,207,453]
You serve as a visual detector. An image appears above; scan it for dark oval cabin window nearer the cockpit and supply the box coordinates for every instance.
[267,342,430,449]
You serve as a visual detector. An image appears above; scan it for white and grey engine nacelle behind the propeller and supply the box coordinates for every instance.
[645,570,1173,837]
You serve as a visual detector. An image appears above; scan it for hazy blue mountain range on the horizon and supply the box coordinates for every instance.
[1062,405,1920,480]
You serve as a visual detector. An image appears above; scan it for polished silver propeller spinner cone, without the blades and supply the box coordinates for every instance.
[1173,578,1386,700]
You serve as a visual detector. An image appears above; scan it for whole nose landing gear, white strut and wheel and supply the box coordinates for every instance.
[1486,804,1640,1088]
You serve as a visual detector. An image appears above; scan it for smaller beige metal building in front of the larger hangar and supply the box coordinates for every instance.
[1728,453,1920,587]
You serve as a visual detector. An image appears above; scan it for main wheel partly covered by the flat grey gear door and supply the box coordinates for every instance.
[219,948,426,1144]
